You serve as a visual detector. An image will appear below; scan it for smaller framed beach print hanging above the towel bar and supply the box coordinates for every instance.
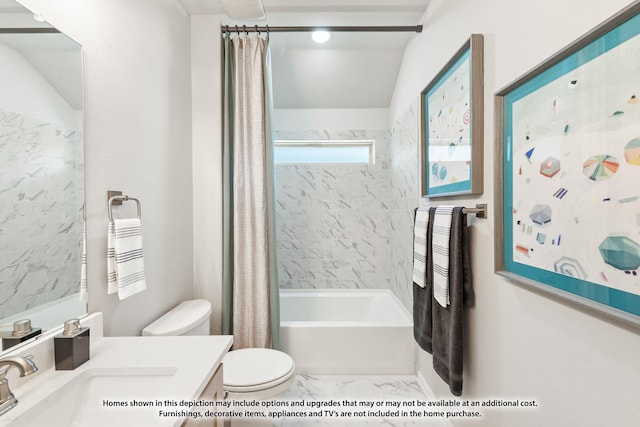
[420,34,484,198]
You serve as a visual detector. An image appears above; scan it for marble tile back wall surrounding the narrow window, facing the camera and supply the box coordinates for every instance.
[276,129,391,289]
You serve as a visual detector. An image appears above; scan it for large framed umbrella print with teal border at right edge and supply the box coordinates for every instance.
[495,2,640,326]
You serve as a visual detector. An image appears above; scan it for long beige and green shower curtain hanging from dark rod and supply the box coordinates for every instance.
[222,32,280,349]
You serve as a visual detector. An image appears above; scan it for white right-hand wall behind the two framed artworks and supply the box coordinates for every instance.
[391,0,640,427]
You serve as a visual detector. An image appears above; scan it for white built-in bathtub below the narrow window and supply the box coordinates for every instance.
[280,289,415,374]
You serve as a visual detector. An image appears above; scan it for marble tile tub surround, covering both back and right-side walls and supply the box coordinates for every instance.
[276,103,419,311]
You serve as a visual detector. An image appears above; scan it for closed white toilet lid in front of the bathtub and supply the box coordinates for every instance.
[222,348,295,391]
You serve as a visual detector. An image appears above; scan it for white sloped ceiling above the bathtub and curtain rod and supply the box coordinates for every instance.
[181,0,430,108]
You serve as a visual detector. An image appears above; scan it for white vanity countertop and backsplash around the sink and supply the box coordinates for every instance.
[0,314,233,426]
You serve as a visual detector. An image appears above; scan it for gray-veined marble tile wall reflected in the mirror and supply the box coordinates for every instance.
[0,109,84,318]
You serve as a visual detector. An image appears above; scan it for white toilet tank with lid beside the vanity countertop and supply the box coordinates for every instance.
[142,299,211,336]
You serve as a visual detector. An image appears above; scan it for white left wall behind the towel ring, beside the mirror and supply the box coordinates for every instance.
[22,0,193,336]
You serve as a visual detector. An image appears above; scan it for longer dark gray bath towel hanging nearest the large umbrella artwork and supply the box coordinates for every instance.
[430,207,473,396]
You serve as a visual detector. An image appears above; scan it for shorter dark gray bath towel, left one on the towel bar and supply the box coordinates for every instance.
[413,208,436,353]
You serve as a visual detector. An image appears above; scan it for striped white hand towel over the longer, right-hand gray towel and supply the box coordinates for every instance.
[432,206,454,307]
